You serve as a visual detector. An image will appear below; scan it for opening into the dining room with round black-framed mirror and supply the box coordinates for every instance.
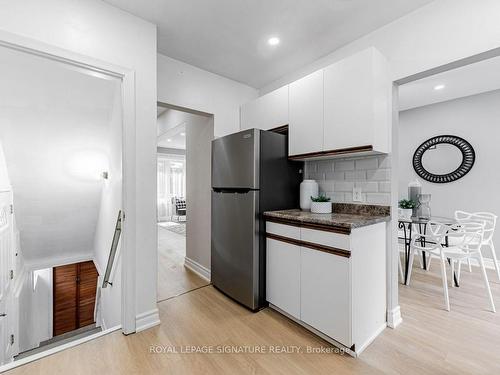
[393,49,500,346]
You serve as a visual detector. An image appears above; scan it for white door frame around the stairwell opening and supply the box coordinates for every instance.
[0,30,136,334]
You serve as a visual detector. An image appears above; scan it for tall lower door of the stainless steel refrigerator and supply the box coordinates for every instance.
[211,191,262,310]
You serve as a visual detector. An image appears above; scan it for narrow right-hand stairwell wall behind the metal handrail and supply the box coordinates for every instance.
[94,87,123,329]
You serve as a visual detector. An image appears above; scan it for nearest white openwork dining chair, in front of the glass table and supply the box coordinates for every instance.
[406,221,496,312]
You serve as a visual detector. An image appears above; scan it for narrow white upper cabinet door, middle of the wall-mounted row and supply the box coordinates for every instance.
[288,70,323,155]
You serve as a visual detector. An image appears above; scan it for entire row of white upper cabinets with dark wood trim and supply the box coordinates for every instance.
[240,47,392,159]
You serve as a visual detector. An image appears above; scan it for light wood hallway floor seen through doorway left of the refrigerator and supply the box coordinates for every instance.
[157,226,208,301]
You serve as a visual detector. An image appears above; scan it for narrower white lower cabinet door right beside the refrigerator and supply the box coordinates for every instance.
[266,238,300,319]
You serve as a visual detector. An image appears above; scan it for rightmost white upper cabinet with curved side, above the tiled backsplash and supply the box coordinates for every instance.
[323,48,392,153]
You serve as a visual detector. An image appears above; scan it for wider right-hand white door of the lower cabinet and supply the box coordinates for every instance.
[300,248,352,347]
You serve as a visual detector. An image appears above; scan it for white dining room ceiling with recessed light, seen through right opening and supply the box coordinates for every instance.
[399,57,500,111]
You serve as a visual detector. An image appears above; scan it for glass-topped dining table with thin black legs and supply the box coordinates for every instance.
[398,216,459,287]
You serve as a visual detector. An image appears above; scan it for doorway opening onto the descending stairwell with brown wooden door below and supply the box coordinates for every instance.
[0,41,123,367]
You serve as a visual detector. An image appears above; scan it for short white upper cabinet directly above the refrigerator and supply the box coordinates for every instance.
[240,85,288,130]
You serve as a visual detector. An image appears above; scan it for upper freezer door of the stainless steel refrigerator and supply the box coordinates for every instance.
[212,129,260,189]
